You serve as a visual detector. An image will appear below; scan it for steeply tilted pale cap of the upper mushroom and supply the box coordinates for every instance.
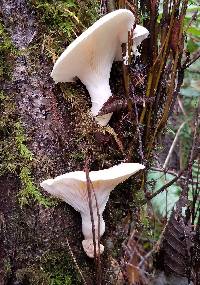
[51,9,135,82]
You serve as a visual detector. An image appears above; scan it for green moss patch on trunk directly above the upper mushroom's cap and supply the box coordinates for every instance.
[30,0,99,61]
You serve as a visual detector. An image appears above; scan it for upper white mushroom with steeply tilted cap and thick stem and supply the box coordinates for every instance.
[51,9,148,126]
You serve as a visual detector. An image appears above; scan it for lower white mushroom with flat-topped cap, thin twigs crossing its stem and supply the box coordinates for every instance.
[41,163,144,258]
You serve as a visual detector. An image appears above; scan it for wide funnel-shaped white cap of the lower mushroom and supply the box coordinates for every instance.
[40,163,144,214]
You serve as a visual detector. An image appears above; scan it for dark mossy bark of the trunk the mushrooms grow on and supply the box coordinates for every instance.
[0,0,143,285]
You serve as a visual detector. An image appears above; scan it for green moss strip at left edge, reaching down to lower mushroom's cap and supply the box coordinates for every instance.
[0,92,53,207]
